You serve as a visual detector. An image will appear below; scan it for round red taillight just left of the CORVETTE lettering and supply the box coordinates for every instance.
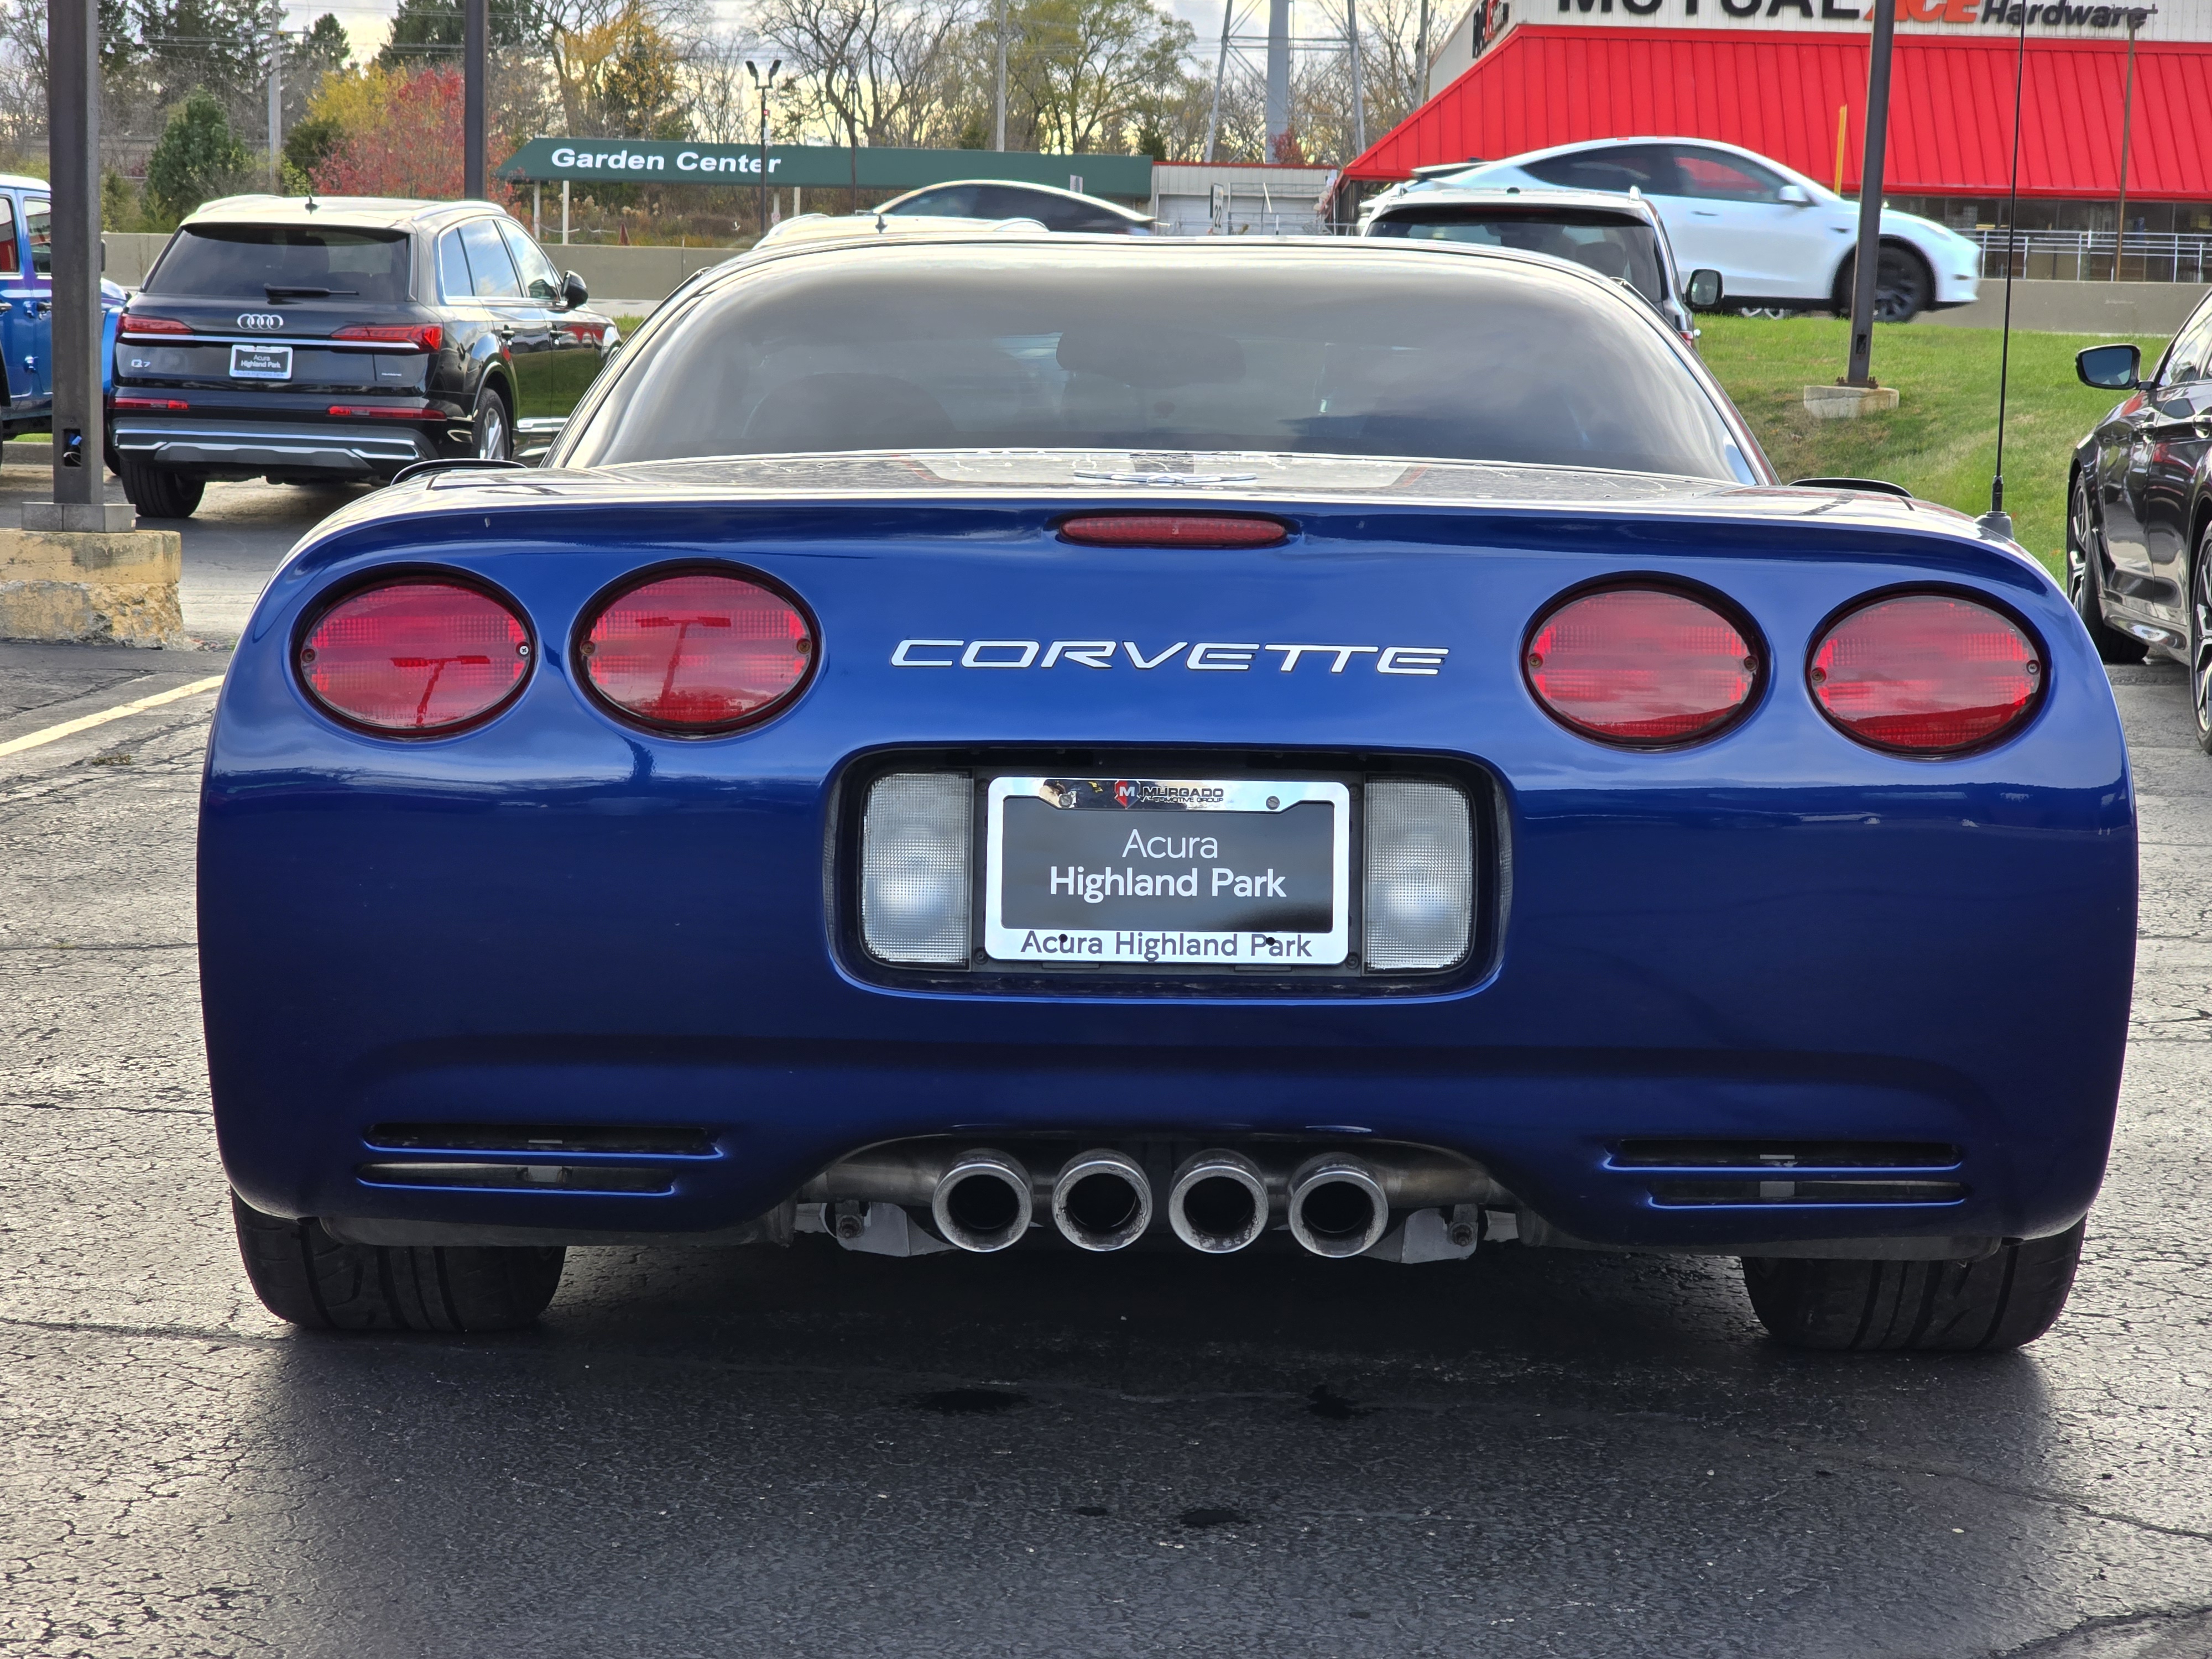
[577,571,814,732]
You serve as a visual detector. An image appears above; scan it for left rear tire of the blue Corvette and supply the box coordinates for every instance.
[230,1192,566,1332]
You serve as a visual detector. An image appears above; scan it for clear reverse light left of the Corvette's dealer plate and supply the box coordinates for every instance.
[860,772,975,967]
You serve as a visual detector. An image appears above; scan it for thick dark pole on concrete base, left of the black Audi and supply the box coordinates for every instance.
[22,0,124,531]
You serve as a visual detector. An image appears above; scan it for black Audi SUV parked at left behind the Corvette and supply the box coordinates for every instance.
[108,197,619,518]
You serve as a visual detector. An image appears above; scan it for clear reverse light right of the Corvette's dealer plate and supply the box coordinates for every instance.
[1360,779,1475,971]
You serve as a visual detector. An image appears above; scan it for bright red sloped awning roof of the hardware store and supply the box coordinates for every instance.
[1345,24,2212,201]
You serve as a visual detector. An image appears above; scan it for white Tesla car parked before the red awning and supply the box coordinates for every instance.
[1387,137,1982,323]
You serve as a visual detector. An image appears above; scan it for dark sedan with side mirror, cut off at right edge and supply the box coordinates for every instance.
[2066,310,2212,752]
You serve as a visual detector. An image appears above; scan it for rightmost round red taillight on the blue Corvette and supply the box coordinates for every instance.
[1807,593,2046,754]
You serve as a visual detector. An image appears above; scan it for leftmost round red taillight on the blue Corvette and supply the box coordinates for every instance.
[299,580,531,732]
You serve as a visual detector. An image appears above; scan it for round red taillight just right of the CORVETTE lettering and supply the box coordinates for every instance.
[1524,588,1759,748]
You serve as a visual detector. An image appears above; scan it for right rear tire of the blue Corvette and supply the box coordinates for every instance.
[1743,1219,2088,1354]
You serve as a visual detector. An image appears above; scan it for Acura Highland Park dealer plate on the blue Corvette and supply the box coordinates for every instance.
[982,779,1352,967]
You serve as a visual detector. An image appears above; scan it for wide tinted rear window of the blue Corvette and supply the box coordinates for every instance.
[557,241,1745,480]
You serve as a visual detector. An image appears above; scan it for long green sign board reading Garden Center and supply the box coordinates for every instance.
[498,139,1152,201]
